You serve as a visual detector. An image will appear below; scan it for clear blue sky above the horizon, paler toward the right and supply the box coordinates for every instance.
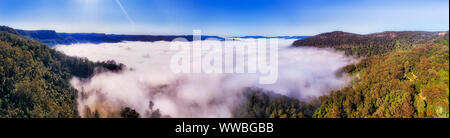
[0,0,449,36]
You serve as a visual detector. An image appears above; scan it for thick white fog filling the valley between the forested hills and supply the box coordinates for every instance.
[55,39,356,117]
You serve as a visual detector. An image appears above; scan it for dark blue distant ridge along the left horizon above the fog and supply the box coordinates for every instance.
[17,29,224,46]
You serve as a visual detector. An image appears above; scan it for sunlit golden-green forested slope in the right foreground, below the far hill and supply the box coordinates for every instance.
[313,33,449,118]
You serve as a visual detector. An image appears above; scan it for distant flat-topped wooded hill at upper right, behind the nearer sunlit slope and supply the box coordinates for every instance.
[293,31,444,57]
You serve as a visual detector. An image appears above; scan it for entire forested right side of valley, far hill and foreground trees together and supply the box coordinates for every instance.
[235,32,449,118]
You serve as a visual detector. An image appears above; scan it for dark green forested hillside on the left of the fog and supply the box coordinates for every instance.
[0,26,123,118]
